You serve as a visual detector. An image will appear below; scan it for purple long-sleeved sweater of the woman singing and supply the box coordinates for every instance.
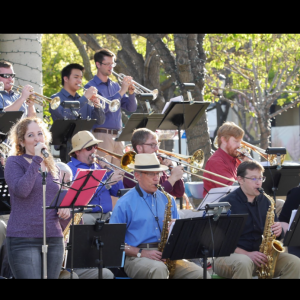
[4,155,63,238]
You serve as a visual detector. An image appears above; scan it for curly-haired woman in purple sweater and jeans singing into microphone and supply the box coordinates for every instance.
[4,118,70,279]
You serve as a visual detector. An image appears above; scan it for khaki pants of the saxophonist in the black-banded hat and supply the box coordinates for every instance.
[124,248,210,279]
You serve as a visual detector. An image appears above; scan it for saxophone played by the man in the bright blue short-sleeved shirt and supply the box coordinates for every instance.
[157,184,176,276]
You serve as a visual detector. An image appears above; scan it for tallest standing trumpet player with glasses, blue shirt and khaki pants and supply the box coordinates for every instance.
[85,49,137,166]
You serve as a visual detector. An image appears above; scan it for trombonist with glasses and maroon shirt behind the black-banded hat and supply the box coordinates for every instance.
[123,128,185,198]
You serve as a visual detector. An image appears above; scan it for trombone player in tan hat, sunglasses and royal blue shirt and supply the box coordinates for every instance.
[68,131,124,225]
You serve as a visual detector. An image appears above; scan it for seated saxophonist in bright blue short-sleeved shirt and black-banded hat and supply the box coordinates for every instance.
[110,153,207,279]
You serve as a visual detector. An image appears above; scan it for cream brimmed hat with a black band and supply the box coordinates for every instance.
[127,153,169,172]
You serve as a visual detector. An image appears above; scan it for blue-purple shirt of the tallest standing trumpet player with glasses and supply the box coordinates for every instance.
[84,75,137,130]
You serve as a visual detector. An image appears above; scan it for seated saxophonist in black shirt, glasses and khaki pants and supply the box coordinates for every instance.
[215,161,300,279]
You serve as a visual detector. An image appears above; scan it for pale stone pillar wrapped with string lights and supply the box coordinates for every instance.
[0,34,43,118]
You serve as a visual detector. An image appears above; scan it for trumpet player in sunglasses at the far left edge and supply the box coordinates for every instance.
[0,61,36,117]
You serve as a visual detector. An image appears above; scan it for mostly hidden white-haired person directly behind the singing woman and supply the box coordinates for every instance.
[56,162,114,279]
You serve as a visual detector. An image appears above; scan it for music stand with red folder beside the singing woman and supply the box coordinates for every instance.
[47,169,106,279]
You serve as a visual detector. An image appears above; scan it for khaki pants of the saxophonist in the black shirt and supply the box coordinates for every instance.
[215,253,300,279]
